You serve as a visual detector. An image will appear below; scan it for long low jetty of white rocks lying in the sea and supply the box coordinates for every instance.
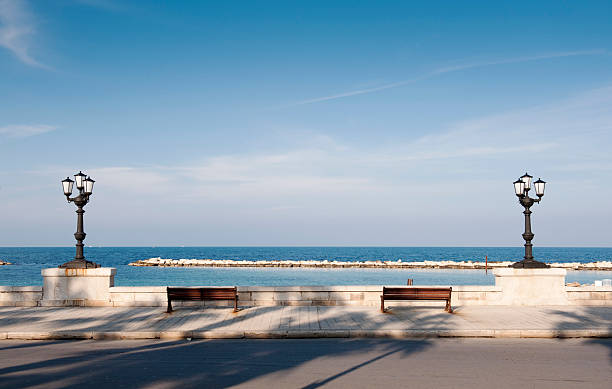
[129,257,612,270]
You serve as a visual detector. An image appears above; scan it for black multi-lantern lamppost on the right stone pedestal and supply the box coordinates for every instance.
[510,173,550,269]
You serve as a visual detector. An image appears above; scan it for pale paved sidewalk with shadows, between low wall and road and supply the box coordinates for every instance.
[0,306,612,339]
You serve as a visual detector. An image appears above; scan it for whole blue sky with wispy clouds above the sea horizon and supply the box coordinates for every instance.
[0,0,612,247]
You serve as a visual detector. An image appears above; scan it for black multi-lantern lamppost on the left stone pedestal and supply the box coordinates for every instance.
[58,172,100,269]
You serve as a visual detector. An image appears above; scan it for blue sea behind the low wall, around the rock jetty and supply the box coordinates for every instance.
[0,246,612,286]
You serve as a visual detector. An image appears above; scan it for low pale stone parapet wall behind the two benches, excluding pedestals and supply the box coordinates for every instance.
[0,285,612,307]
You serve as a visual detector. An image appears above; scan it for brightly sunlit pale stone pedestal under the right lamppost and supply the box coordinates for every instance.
[493,268,568,305]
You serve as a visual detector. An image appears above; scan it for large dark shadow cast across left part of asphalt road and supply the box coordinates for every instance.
[0,339,430,388]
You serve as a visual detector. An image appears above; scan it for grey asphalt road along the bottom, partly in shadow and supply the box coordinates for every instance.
[0,339,612,389]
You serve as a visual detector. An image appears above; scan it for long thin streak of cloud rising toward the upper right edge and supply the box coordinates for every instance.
[283,50,606,107]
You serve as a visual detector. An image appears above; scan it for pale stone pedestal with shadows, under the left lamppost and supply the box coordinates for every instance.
[41,267,117,306]
